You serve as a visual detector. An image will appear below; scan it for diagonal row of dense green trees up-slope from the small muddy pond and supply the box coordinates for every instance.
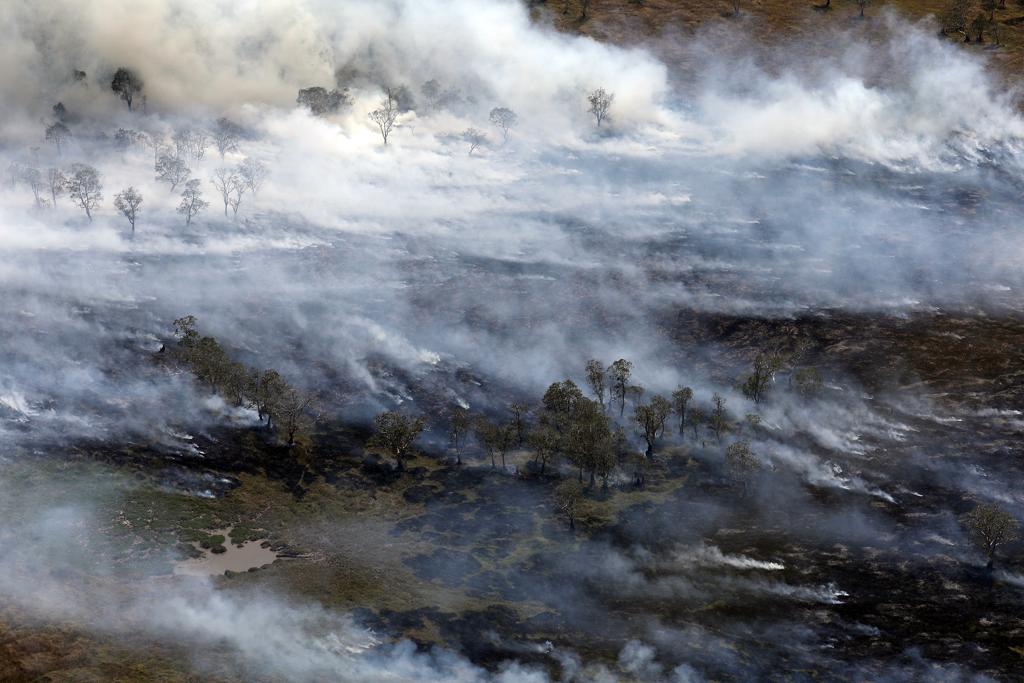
[174,315,318,446]
